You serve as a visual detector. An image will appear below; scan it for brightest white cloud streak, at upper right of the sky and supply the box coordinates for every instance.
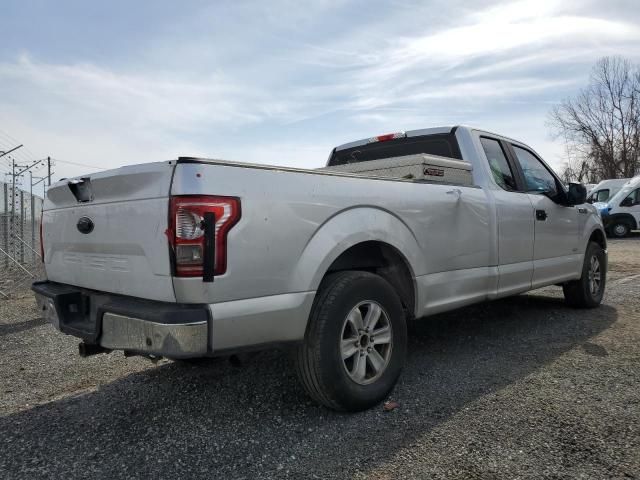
[336,0,640,98]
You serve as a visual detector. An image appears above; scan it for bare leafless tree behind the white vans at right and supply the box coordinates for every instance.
[550,57,640,183]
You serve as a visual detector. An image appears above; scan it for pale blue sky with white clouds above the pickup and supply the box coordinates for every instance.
[0,0,640,185]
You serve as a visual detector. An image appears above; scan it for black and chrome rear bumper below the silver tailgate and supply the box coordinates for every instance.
[32,281,211,358]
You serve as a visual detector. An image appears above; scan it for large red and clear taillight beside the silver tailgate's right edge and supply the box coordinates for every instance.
[169,195,240,277]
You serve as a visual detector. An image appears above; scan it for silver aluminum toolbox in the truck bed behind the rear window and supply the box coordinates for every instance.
[321,154,473,185]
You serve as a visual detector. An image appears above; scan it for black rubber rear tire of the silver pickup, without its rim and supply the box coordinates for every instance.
[295,271,407,411]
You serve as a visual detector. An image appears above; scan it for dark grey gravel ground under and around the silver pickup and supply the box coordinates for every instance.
[0,236,640,479]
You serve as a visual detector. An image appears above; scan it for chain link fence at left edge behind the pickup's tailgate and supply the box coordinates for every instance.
[0,182,44,300]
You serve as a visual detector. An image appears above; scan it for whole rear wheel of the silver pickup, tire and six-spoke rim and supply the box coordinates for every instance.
[296,271,407,411]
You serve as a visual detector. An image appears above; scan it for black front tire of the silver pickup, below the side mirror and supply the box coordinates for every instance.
[562,242,607,308]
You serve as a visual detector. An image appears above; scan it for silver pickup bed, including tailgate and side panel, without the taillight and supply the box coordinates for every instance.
[43,157,490,303]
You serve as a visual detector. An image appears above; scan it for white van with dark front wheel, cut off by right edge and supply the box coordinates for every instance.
[599,175,640,238]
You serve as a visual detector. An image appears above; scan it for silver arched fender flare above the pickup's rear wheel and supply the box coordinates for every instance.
[289,206,422,292]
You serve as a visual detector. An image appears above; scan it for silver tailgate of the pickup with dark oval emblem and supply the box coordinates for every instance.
[42,162,175,301]
